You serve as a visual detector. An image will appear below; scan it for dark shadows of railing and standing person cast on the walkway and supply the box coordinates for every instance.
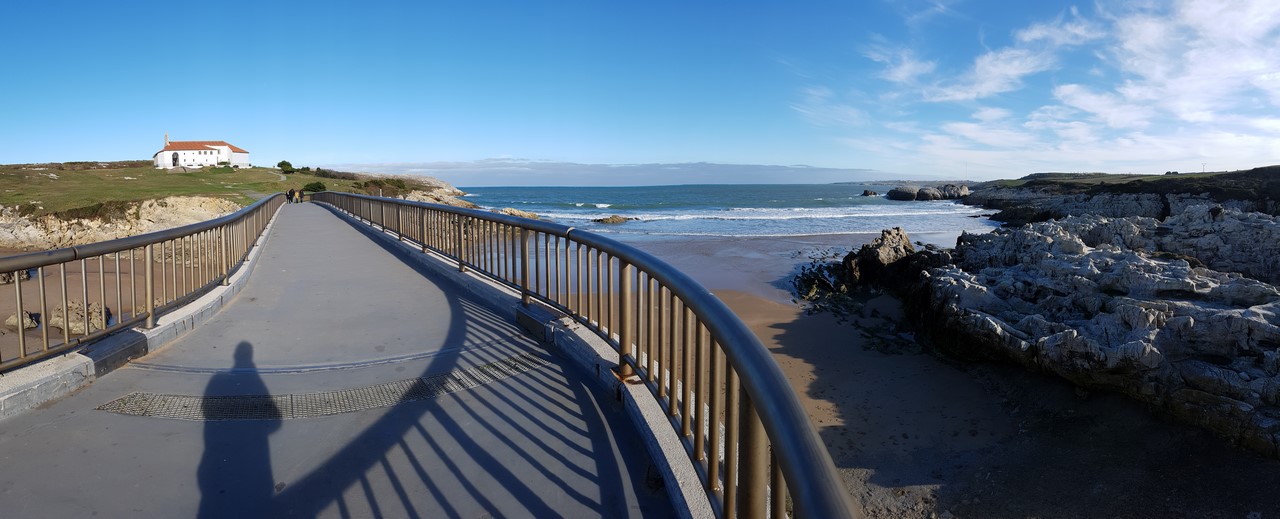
[198,208,671,518]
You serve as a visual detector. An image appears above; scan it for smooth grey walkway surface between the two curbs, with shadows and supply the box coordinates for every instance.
[0,204,671,519]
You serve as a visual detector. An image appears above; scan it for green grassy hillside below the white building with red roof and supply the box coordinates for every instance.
[0,160,445,218]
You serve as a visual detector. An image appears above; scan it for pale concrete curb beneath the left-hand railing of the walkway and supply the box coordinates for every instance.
[0,210,279,419]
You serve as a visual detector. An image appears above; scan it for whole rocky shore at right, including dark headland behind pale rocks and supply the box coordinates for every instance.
[797,167,1280,457]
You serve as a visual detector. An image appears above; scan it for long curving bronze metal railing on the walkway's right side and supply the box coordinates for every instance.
[312,192,854,518]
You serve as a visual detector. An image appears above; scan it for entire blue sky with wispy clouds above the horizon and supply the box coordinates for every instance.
[0,0,1280,186]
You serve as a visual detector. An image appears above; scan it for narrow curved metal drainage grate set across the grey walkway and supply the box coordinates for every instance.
[97,352,548,420]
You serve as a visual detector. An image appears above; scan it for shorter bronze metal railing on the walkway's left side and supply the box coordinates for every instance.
[0,194,284,373]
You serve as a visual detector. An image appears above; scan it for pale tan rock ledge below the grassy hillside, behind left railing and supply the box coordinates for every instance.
[0,196,239,250]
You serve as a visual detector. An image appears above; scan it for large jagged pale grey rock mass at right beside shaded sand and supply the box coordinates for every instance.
[911,216,1280,456]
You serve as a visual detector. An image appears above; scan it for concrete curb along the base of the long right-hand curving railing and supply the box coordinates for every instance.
[317,206,716,519]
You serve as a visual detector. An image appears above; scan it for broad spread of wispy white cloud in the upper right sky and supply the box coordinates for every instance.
[808,0,1280,176]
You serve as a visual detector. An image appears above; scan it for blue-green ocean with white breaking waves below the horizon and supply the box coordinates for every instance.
[462,183,998,241]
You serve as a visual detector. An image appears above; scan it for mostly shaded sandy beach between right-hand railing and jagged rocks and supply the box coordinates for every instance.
[634,235,1280,519]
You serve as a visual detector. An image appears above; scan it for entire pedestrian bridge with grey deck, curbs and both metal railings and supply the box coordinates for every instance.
[0,194,852,518]
